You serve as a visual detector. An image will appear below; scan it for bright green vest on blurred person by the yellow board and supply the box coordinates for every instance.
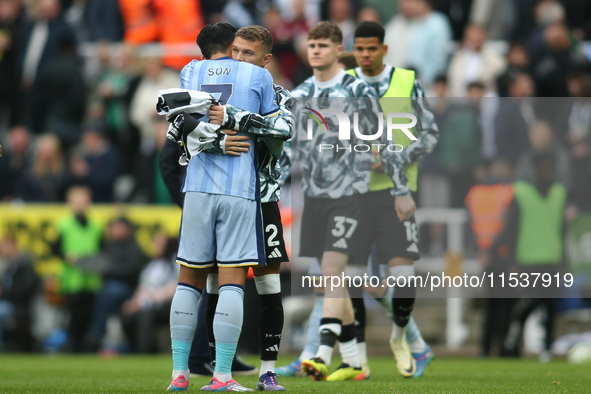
[58,216,102,294]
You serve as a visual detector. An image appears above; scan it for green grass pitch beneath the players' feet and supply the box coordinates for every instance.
[0,355,591,394]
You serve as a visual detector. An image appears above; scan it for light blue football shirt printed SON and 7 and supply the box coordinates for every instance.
[181,57,279,201]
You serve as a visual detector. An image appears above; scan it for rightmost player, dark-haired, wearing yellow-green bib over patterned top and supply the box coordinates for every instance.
[347,22,439,377]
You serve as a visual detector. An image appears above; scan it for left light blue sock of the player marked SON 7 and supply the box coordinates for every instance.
[170,283,201,371]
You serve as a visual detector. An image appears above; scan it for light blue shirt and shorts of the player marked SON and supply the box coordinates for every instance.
[177,36,279,267]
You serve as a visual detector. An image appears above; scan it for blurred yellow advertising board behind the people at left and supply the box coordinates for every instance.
[0,204,181,276]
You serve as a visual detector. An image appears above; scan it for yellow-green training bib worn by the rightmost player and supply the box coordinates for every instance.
[347,68,419,192]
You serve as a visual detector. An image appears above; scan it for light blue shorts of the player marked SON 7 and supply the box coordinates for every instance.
[176,192,266,268]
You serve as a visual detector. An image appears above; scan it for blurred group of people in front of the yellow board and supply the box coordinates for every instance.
[0,185,179,353]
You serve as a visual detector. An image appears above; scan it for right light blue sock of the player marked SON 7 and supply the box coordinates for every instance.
[213,284,244,377]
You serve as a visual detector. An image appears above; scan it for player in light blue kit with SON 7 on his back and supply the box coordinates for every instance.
[168,23,279,391]
